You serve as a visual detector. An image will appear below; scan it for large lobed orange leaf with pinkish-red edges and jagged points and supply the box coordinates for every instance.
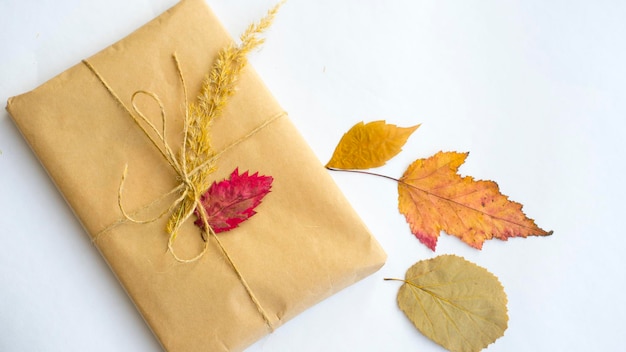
[398,152,552,250]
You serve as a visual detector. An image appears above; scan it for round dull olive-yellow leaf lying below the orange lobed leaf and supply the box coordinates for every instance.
[387,255,508,352]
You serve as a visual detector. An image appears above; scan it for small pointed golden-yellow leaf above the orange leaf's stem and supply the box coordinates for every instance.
[326,120,420,169]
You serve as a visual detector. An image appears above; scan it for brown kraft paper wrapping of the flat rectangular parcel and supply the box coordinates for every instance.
[7,0,385,351]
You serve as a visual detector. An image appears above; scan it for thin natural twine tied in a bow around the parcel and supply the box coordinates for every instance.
[82,53,278,331]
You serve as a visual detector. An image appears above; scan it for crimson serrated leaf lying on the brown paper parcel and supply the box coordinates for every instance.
[194,169,274,233]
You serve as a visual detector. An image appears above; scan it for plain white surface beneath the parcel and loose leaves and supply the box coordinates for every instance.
[0,0,626,352]
